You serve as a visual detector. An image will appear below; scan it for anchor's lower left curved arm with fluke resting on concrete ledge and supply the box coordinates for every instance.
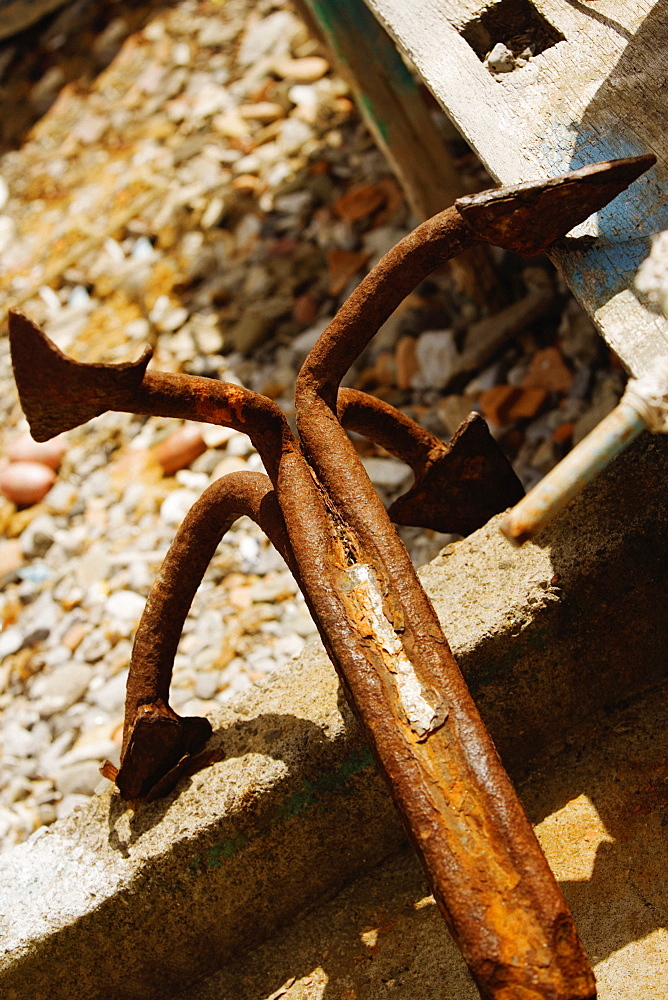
[102,472,295,801]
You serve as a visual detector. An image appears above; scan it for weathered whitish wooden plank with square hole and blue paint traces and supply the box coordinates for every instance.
[366,0,668,375]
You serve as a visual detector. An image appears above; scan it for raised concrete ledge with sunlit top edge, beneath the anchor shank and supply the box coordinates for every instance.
[0,436,668,1000]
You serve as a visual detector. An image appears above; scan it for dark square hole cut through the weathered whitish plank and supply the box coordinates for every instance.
[460,0,565,65]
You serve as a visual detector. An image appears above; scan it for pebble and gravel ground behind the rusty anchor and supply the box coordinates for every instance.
[0,0,625,849]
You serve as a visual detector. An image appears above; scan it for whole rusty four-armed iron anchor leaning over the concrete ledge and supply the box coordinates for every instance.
[9,156,655,1000]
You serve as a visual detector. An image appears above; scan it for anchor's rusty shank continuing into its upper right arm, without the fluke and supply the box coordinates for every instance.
[294,209,595,1000]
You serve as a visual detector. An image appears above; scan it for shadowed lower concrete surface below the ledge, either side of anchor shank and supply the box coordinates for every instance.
[179,688,668,1000]
